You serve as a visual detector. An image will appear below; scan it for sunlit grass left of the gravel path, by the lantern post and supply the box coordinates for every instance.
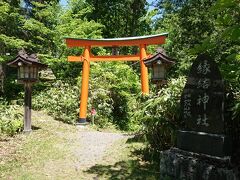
[0,112,75,179]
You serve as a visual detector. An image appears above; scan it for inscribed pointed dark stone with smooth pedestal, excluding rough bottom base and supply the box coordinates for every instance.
[177,55,232,157]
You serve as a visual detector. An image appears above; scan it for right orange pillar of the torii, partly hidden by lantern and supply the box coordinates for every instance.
[140,44,149,94]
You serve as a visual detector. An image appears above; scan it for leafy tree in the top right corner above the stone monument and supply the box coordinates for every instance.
[153,0,239,76]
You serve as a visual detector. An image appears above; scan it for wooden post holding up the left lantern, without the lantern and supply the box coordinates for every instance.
[23,82,32,132]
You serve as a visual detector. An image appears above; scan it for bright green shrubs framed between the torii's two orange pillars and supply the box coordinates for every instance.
[85,62,140,130]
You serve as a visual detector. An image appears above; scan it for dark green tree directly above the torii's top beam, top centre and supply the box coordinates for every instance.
[87,0,150,38]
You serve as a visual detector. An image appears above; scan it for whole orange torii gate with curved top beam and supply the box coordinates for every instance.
[66,33,167,123]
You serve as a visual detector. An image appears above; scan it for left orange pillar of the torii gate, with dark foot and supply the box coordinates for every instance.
[78,46,91,124]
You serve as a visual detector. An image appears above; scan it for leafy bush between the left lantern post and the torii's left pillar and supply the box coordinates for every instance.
[32,80,79,123]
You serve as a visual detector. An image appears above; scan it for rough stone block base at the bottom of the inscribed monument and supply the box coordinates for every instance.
[160,148,240,180]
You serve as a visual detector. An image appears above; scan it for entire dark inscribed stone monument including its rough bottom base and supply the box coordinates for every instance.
[160,55,239,180]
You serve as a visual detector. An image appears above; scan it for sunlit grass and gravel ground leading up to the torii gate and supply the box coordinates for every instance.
[0,112,159,180]
